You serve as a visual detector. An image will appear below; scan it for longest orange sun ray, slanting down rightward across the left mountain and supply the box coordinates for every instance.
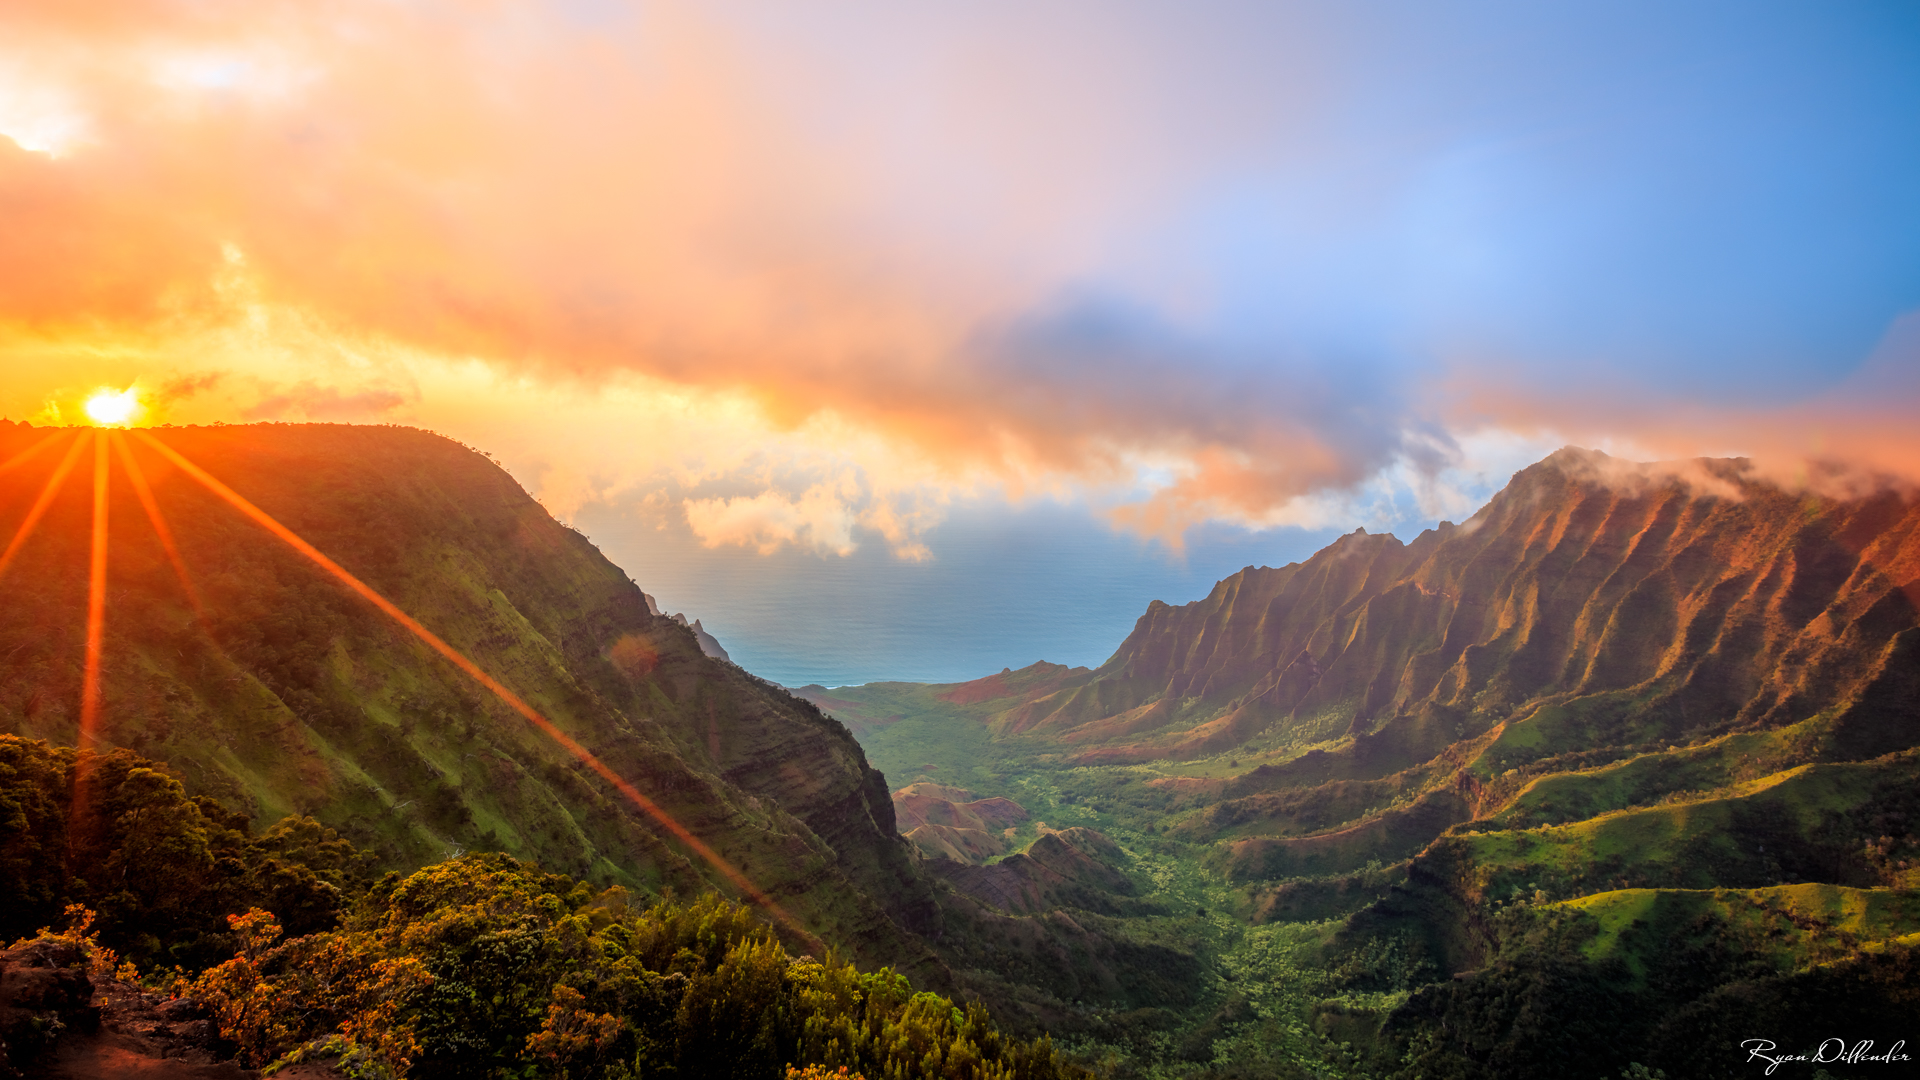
[132,430,812,938]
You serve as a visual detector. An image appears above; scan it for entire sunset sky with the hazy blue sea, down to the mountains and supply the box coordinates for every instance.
[0,0,1920,684]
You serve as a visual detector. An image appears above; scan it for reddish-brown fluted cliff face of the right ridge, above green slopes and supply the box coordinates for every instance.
[936,450,1920,778]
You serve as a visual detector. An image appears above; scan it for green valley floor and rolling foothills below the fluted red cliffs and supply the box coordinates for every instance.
[817,668,1920,1080]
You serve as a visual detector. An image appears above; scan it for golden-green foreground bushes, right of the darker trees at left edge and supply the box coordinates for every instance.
[184,855,1081,1080]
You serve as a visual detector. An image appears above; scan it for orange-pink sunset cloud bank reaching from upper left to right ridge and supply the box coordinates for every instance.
[0,0,1920,545]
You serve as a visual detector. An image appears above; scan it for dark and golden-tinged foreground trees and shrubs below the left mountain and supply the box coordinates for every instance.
[0,736,1081,1080]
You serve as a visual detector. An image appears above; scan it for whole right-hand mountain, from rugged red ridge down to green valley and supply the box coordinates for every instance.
[803,450,1920,1076]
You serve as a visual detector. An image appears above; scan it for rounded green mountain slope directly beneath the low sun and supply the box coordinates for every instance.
[0,423,945,986]
